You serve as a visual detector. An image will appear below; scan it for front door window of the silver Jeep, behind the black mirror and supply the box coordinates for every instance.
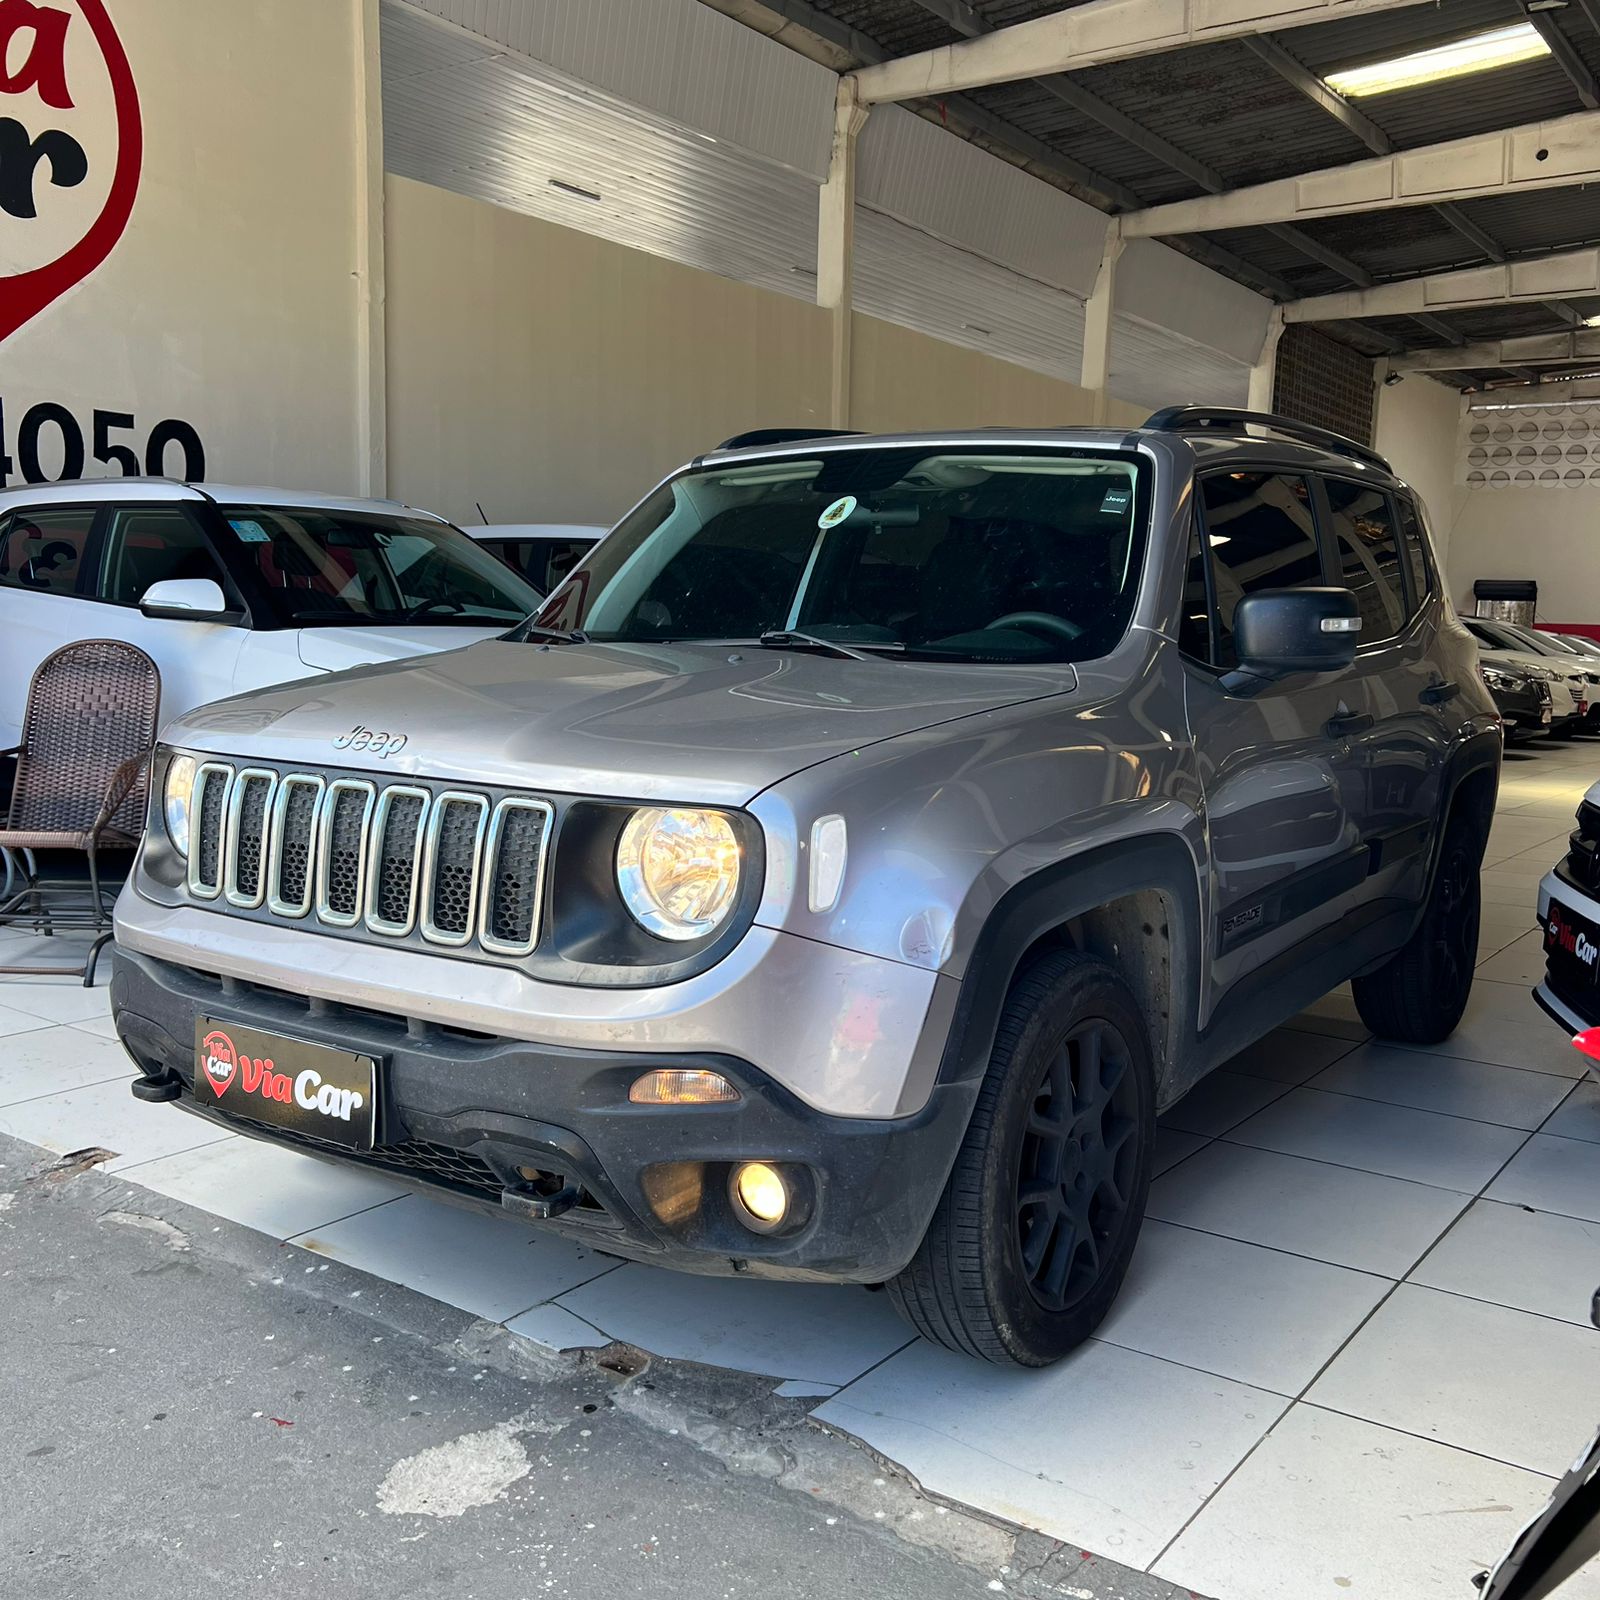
[1202,472,1325,667]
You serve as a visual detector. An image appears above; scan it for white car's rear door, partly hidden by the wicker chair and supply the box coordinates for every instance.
[0,506,103,750]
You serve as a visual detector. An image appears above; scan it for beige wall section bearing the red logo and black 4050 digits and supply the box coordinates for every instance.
[0,0,362,491]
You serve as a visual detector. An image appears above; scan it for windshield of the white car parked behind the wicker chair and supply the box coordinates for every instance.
[218,506,542,627]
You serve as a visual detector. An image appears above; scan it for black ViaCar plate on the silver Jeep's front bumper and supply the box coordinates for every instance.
[194,1016,382,1150]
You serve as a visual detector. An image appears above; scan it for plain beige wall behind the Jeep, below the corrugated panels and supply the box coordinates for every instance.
[386,178,1142,523]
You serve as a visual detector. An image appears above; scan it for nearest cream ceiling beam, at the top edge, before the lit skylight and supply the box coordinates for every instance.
[856,0,1430,104]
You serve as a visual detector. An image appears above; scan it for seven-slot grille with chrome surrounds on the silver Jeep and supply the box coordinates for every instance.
[189,762,552,957]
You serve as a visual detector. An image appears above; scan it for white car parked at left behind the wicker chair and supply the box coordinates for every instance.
[0,478,542,749]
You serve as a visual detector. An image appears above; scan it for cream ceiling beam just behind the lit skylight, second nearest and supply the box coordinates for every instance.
[1120,110,1600,238]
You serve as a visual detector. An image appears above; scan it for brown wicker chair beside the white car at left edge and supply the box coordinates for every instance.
[0,638,162,987]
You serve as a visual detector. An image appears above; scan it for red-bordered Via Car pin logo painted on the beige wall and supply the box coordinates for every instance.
[0,0,144,341]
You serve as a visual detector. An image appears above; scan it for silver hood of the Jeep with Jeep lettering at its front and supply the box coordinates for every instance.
[165,640,1077,805]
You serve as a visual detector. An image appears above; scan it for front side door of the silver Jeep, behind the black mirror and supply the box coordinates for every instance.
[1181,469,1368,1005]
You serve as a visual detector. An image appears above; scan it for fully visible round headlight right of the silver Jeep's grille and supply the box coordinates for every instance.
[616,806,739,939]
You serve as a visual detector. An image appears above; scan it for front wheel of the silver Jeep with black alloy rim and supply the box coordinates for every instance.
[888,952,1155,1366]
